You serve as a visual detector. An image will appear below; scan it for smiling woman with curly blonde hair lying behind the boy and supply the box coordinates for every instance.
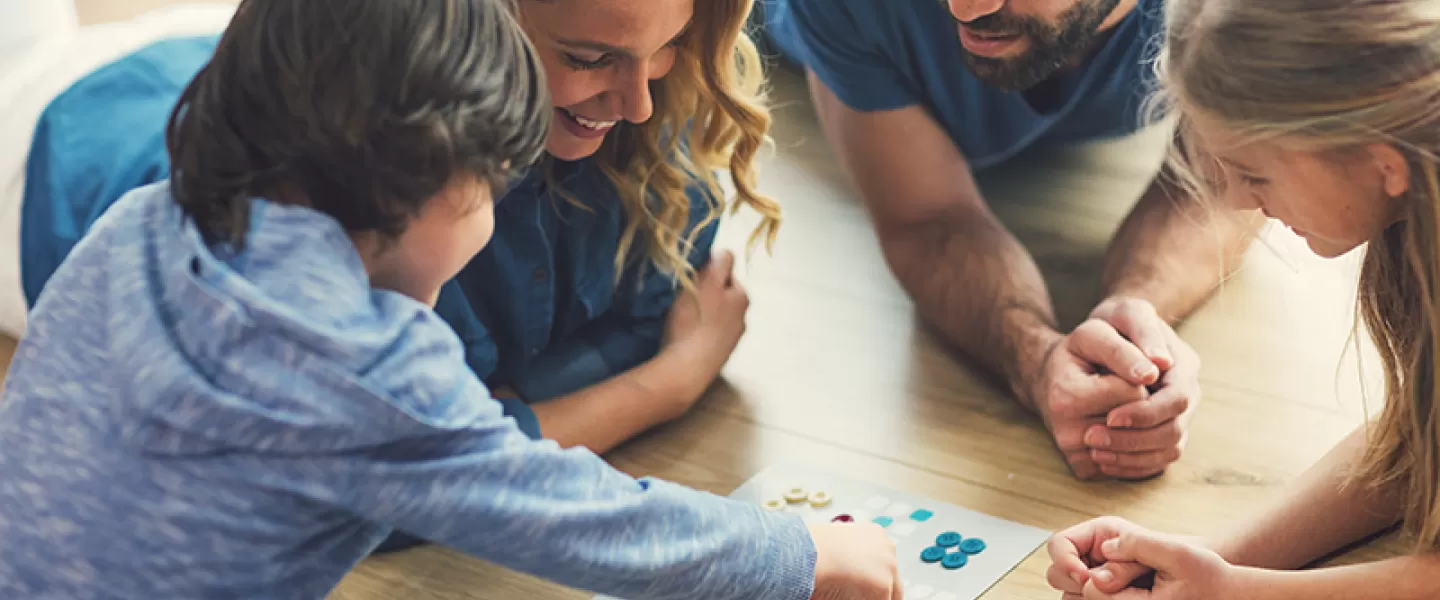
[0,0,779,546]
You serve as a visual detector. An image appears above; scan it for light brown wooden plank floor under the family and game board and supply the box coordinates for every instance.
[33,0,1400,600]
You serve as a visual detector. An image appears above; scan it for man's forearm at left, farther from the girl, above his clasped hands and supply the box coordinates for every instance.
[881,209,1060,406]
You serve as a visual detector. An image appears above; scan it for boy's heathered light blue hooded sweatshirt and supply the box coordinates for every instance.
[0,183,815,600]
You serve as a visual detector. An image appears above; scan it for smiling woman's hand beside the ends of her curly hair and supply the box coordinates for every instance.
[662,250,750,378]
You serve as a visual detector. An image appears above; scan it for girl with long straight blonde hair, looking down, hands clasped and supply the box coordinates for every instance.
[1050,0,1440,600]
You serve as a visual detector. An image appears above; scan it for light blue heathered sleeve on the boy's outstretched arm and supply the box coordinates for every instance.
[324,378,816,600]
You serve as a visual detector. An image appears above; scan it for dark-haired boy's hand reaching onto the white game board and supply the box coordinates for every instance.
[809,524,904,600]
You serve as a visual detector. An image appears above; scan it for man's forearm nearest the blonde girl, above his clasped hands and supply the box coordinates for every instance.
[1102,174,1264,325]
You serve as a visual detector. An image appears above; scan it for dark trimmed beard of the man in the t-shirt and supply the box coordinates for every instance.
[958,0,1120,91]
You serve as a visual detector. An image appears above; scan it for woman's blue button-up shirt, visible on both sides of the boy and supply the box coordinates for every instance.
[20,36,717,437]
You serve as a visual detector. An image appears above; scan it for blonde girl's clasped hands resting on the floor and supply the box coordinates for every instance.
[1047,517,1236,600]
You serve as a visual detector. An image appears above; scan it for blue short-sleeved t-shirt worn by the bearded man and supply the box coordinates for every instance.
[765,0,1162,170]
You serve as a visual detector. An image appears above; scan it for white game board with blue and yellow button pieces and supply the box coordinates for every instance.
[596,465,1050,600]
